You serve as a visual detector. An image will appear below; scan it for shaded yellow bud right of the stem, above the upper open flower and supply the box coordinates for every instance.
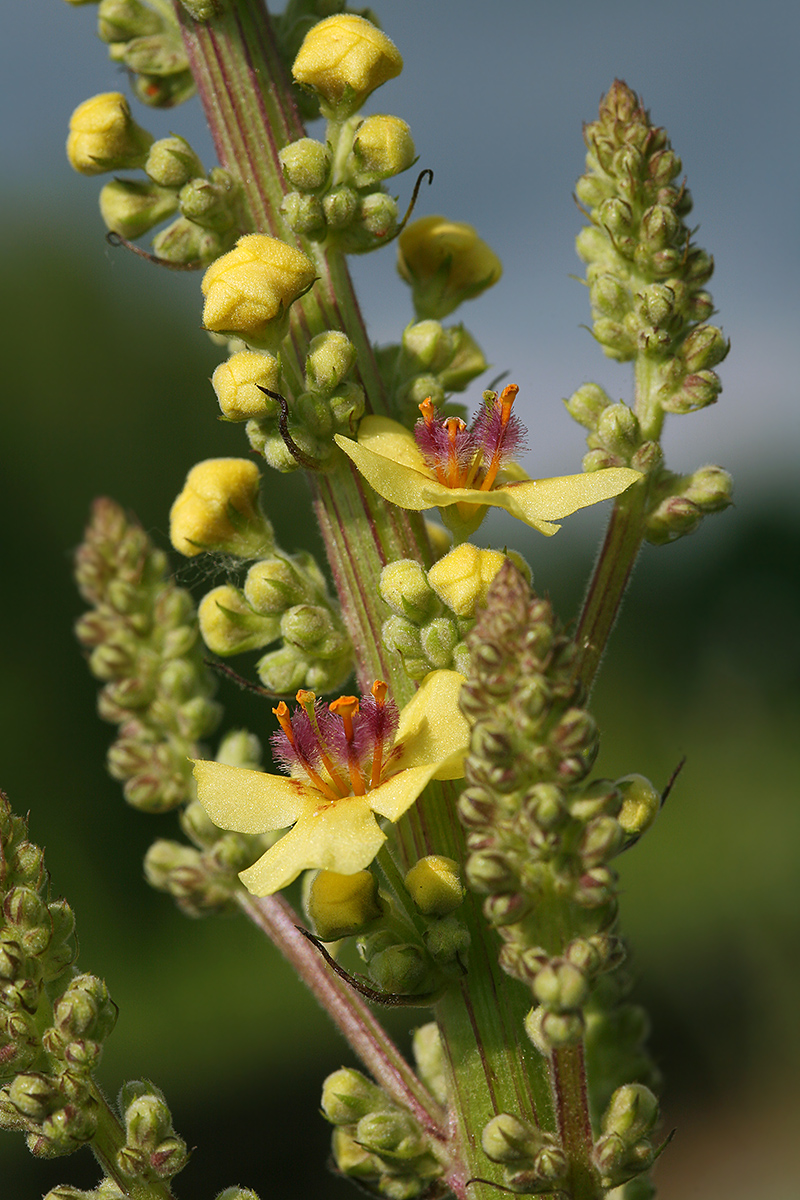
[397,216,503,320]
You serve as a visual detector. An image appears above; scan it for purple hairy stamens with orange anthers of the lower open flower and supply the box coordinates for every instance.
[272,679,398,802]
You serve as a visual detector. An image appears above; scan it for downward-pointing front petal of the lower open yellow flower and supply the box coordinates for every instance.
[239,794,386,896]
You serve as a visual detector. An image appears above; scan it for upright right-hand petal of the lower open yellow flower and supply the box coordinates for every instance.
[393,671,470,786]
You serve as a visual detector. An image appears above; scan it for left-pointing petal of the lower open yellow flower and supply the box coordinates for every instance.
[194,760,320,840]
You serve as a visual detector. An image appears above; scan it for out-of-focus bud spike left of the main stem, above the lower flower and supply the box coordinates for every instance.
[76,499,219,812]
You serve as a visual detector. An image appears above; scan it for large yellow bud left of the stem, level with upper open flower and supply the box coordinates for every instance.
[169,458,273,558]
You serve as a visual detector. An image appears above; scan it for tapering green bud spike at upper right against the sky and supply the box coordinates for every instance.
[576,80,728,393]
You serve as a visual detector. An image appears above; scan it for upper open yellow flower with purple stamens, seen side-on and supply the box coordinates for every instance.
[336,385,642,540]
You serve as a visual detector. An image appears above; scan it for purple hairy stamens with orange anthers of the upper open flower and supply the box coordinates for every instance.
[414,384,525,492]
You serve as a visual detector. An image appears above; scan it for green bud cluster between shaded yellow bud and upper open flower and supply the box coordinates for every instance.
[375,320,488,425]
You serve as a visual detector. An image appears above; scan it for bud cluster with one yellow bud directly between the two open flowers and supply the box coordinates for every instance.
[380,542,530,679]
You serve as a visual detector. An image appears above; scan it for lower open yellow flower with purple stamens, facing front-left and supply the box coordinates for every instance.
[194,671,469,896]
